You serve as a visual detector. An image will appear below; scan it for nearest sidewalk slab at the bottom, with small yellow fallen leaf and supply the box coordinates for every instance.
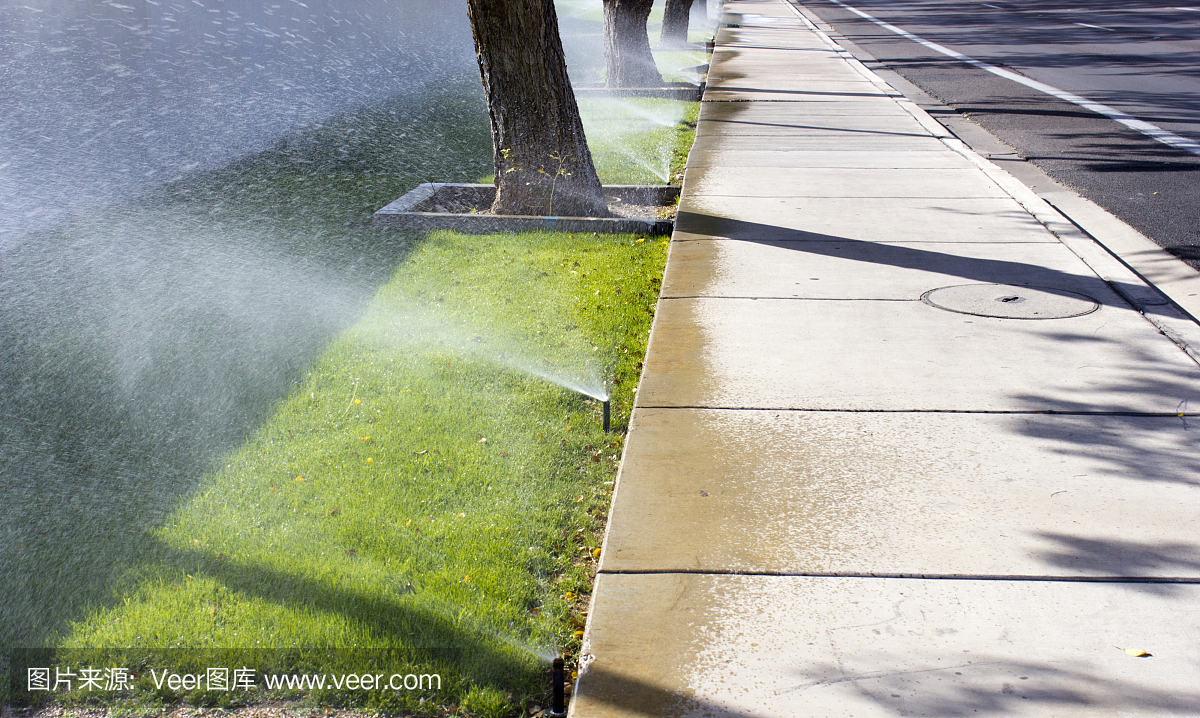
[571,574,1200,718]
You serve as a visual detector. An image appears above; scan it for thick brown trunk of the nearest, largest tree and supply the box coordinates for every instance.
[467,0,608,217]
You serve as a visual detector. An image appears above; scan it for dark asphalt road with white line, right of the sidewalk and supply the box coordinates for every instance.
[793,0,1200,269]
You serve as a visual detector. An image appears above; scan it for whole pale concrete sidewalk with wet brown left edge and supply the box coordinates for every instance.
[571,0,1200,718]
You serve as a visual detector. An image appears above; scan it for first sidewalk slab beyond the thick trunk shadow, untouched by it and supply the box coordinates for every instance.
[684,166,1008,199]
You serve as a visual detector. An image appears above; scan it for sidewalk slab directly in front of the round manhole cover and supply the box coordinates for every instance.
[637,296,1200,414]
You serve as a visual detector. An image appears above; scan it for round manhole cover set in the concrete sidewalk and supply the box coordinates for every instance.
[920,285,1100,319]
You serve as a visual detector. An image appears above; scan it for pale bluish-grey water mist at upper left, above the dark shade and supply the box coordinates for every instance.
[0,0,474,247]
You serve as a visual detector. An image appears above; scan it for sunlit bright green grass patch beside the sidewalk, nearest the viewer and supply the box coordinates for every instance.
[62,228,666,711]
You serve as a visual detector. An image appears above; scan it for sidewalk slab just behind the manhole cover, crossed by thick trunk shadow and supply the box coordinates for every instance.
[660,238,1118,303]
